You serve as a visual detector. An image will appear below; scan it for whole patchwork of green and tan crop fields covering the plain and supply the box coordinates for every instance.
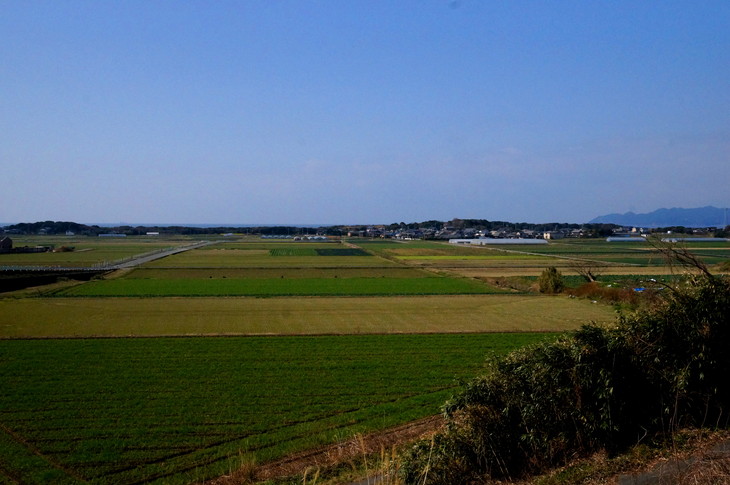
[0,234,708,483]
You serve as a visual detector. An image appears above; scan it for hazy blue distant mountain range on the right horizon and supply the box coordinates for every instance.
[589,206,730,227]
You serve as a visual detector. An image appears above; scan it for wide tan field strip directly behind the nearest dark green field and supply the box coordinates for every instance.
[0,295,615,338]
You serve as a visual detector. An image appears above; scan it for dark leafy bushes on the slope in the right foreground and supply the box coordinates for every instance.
[402,268,730,484]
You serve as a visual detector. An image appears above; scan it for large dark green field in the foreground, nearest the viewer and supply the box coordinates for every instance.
[0,334,546,484]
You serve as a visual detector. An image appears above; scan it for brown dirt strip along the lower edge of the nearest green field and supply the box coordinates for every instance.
[203,416,443,485]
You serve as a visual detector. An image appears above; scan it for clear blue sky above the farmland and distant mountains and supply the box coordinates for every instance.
[0,0,730,224]
